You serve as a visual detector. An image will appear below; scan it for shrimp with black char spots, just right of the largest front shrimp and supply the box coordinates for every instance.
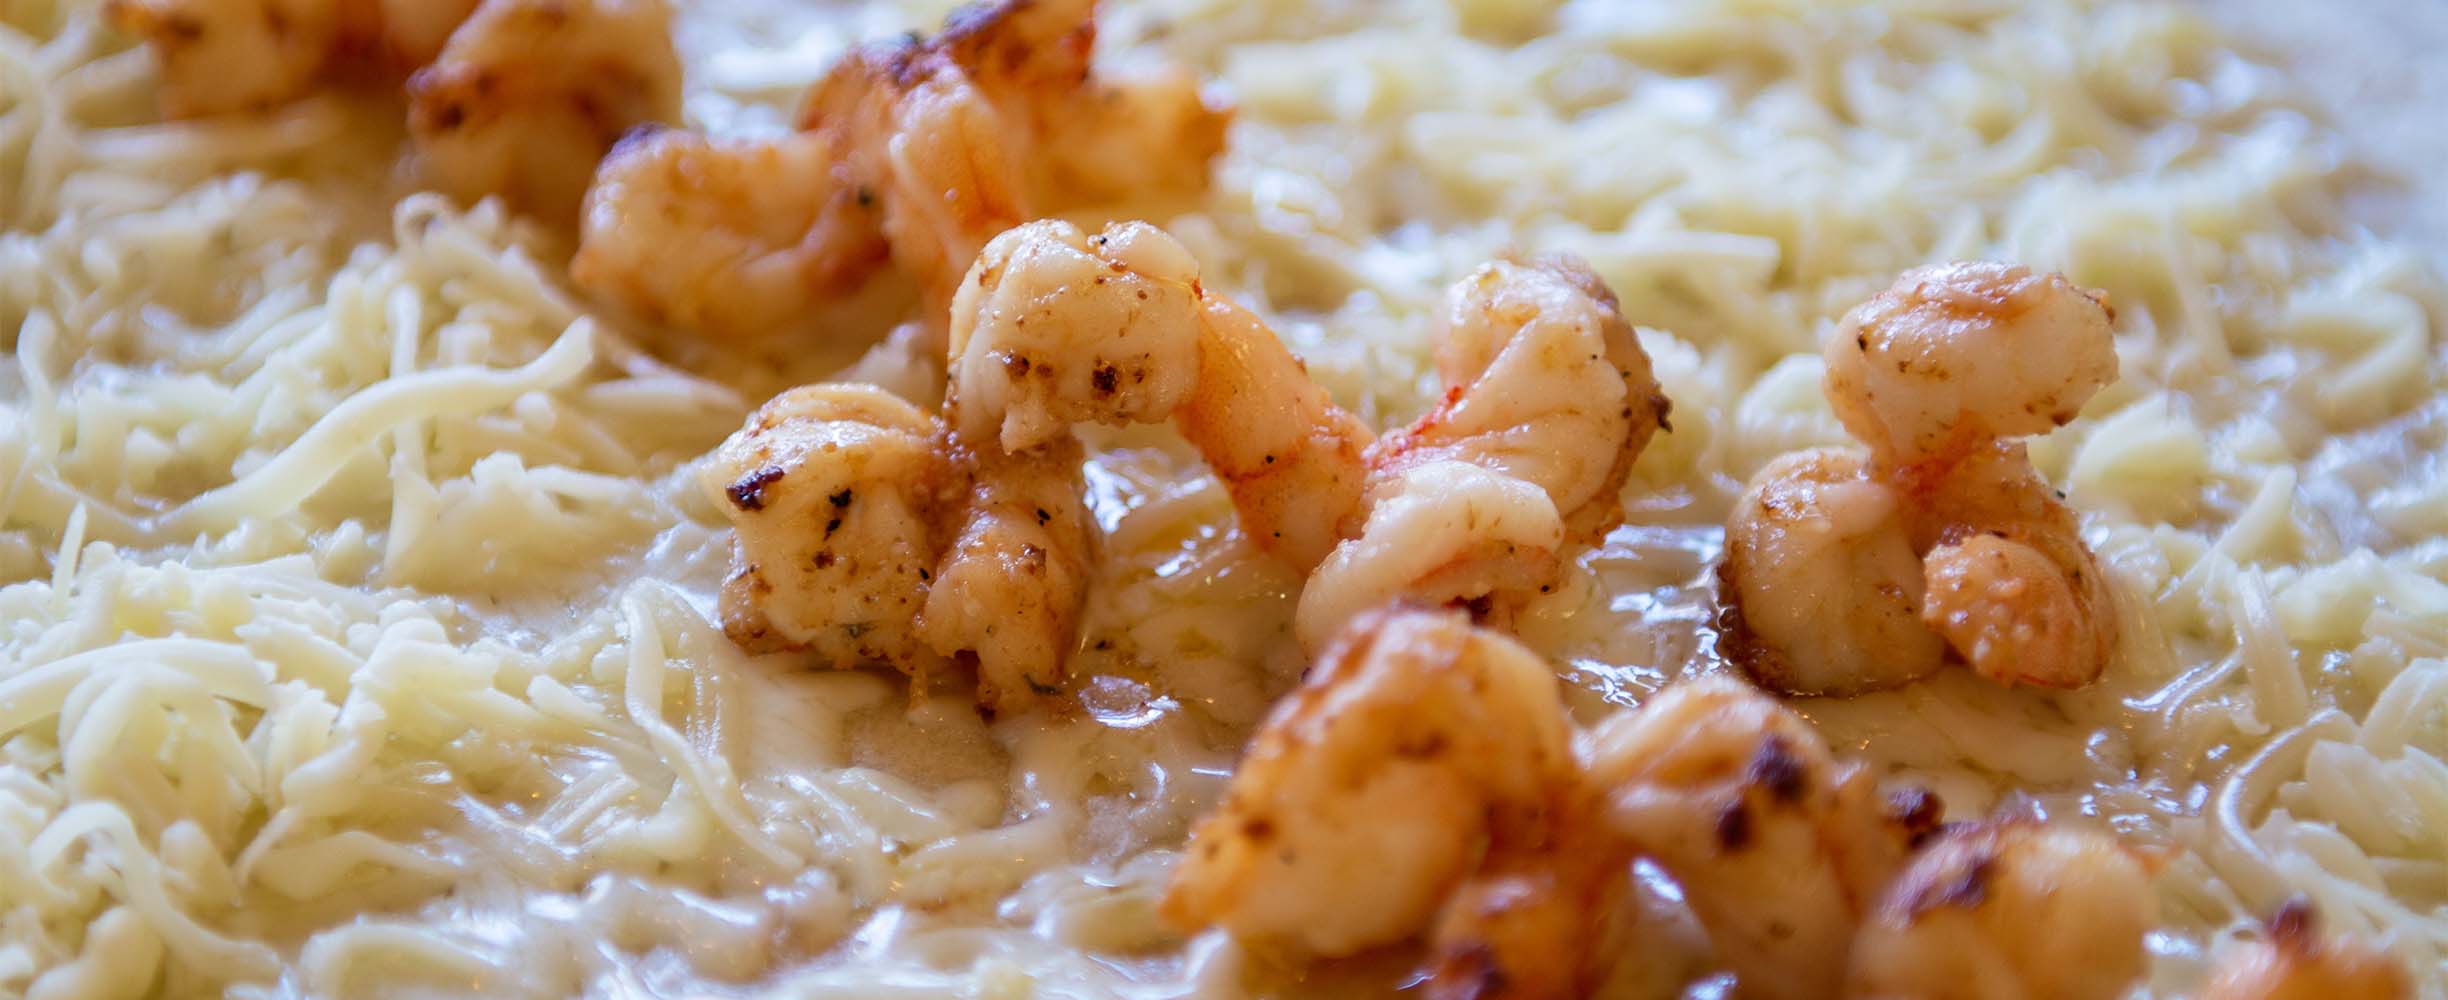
[1584,676,1936,998]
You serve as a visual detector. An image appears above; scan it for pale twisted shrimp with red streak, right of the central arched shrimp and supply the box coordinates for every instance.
[1295,257,1670,647]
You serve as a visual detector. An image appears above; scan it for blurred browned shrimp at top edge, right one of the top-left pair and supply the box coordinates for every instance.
[409,0,681,223]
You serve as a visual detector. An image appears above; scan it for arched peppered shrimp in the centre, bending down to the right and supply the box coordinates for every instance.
[925,221,1368,569]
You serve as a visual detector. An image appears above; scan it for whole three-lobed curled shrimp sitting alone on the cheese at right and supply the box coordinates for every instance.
[1718,265,2118,694]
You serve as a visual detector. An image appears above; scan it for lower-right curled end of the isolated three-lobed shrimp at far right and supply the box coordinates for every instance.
[1919,441,2118,689]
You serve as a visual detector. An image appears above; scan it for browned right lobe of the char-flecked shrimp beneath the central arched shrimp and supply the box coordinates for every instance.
[918,434,1089,711]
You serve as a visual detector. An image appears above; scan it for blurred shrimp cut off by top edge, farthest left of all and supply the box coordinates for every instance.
[103,0,480,118]
